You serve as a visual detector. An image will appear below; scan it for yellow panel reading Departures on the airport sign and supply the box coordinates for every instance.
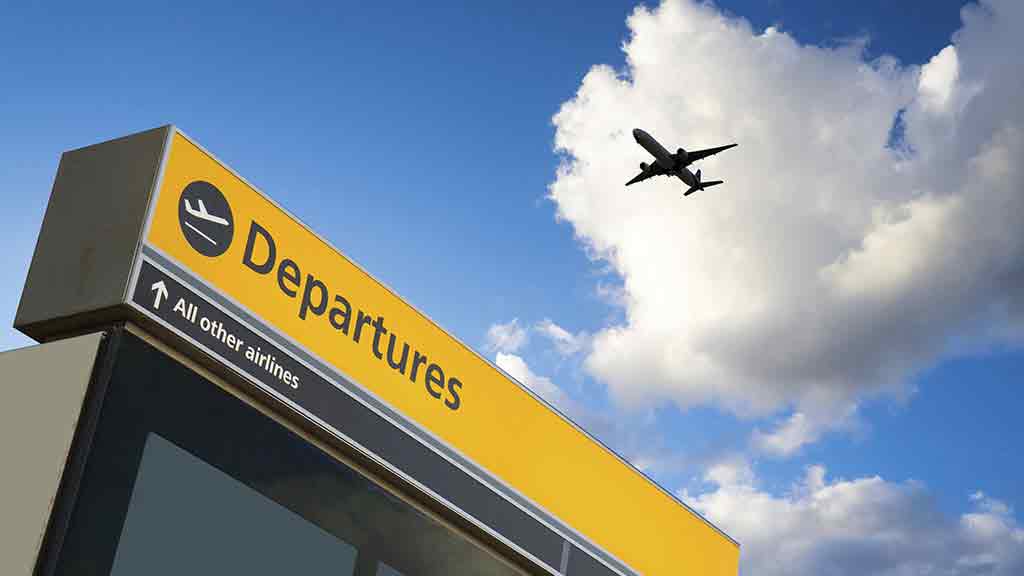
[145,131,739,575]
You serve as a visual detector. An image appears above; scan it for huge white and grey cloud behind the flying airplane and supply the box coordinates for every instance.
[549,0,1024,422]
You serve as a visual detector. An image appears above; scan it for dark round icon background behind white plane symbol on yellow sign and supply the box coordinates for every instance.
[178,180,234,256]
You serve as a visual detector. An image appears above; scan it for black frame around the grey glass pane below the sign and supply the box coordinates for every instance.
[35,327,519,576]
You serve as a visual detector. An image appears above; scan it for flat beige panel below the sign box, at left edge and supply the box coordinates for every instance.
[0,333,102,576]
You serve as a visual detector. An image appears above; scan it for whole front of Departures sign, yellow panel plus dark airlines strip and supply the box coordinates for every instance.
[19,127,738,575]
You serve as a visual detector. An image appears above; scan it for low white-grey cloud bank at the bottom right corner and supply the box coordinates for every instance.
[682,460,1024,576]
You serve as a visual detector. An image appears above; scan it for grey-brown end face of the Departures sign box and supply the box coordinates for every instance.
[14,127,169,340]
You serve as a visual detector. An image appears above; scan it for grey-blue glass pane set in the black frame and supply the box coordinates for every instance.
[112,434,356,576]
